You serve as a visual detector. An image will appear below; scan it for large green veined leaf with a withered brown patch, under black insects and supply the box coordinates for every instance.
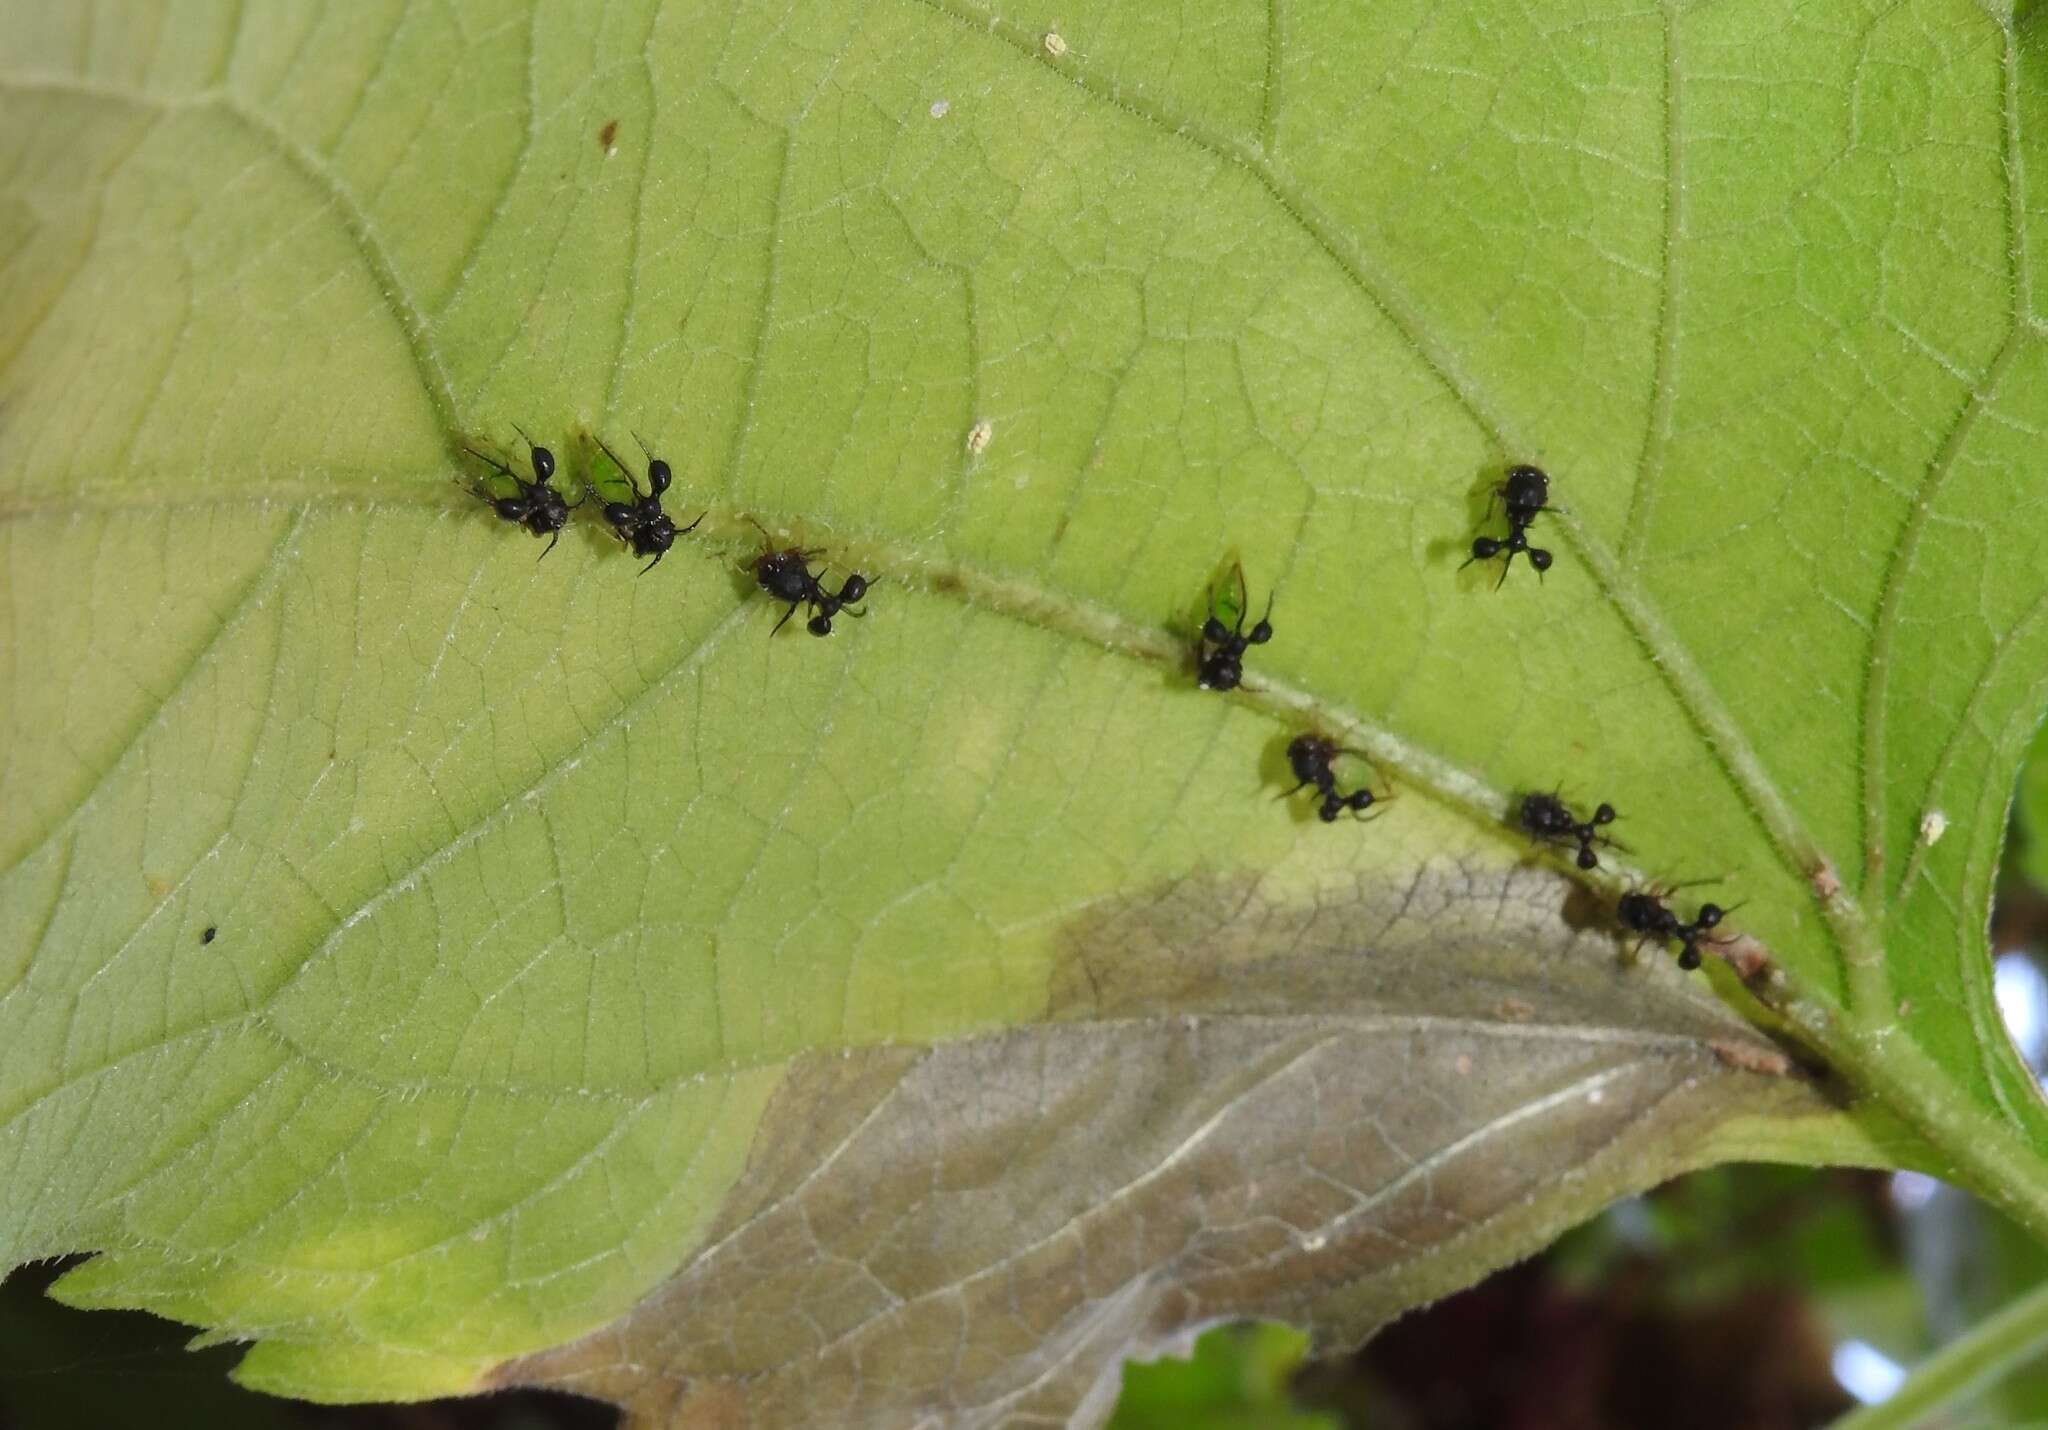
[0,0,2048,1426]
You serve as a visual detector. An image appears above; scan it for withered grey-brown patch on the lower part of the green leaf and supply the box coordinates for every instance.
[498,869,1882,1426]
